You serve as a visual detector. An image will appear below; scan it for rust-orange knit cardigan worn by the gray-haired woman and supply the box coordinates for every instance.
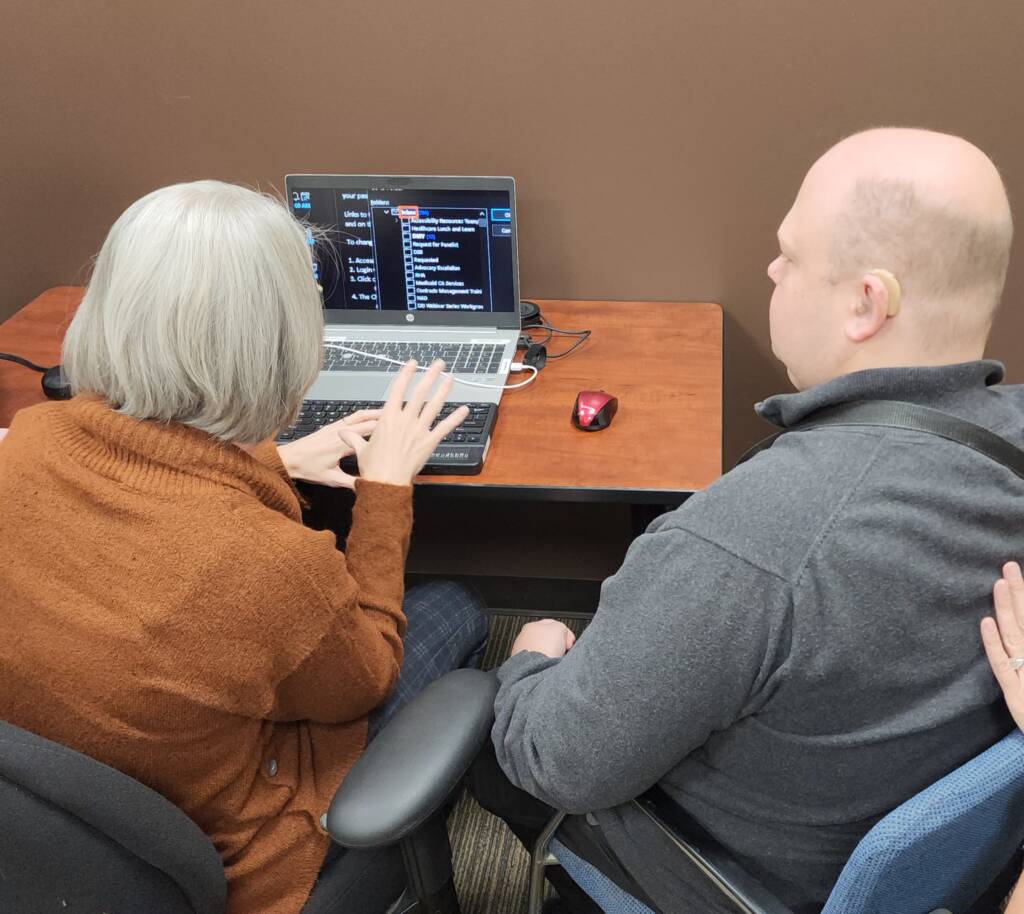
[0,397,412,914]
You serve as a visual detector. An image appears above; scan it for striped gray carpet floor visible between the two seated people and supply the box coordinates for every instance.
[449,612,586,914]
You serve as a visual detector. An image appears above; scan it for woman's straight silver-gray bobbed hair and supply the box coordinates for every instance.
[63,181,323,443]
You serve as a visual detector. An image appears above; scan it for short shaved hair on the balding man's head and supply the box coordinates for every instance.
[830,177,1014,335]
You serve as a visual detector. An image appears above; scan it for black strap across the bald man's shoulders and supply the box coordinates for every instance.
[736,400,1024,479]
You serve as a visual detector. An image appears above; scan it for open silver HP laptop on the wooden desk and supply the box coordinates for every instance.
[285,175,520,473]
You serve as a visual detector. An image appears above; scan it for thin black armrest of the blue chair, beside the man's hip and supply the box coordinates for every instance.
[634,787,793,914]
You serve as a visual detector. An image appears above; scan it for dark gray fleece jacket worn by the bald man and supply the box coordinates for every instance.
[493,361,1024,914]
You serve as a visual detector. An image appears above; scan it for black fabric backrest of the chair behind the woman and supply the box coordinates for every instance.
[0,712,225,914]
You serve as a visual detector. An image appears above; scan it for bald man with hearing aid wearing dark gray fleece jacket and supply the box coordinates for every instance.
[471,129,1024,914]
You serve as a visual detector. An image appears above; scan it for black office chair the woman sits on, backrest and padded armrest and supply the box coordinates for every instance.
[0,669,497,914]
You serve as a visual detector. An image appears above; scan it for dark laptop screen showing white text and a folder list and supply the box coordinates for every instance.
[291,185,516,312]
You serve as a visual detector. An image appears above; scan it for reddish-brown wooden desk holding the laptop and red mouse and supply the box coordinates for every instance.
[0,287,722,506]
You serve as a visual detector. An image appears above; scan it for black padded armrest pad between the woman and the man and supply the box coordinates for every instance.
[327,669,498,847]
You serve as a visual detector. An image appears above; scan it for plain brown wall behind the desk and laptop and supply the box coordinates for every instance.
[0,0,1024,460]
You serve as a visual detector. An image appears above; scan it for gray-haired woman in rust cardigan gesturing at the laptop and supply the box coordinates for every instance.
[0,181,486,914]
